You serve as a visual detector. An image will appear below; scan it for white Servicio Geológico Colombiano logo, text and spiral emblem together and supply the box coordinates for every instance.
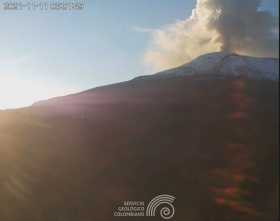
[113,194,176,220]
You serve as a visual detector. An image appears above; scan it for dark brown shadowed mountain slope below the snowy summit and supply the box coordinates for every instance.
[0,75,279,221]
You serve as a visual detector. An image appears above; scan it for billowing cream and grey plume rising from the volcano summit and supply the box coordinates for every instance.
[145,0,279,70]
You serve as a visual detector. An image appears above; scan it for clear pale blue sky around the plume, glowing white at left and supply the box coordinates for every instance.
[0,0,278,109]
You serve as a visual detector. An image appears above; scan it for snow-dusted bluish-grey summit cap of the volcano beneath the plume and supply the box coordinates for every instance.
[149,52,279,80]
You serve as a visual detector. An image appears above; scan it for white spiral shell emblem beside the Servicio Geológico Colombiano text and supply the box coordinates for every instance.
[146,195,176,220]
